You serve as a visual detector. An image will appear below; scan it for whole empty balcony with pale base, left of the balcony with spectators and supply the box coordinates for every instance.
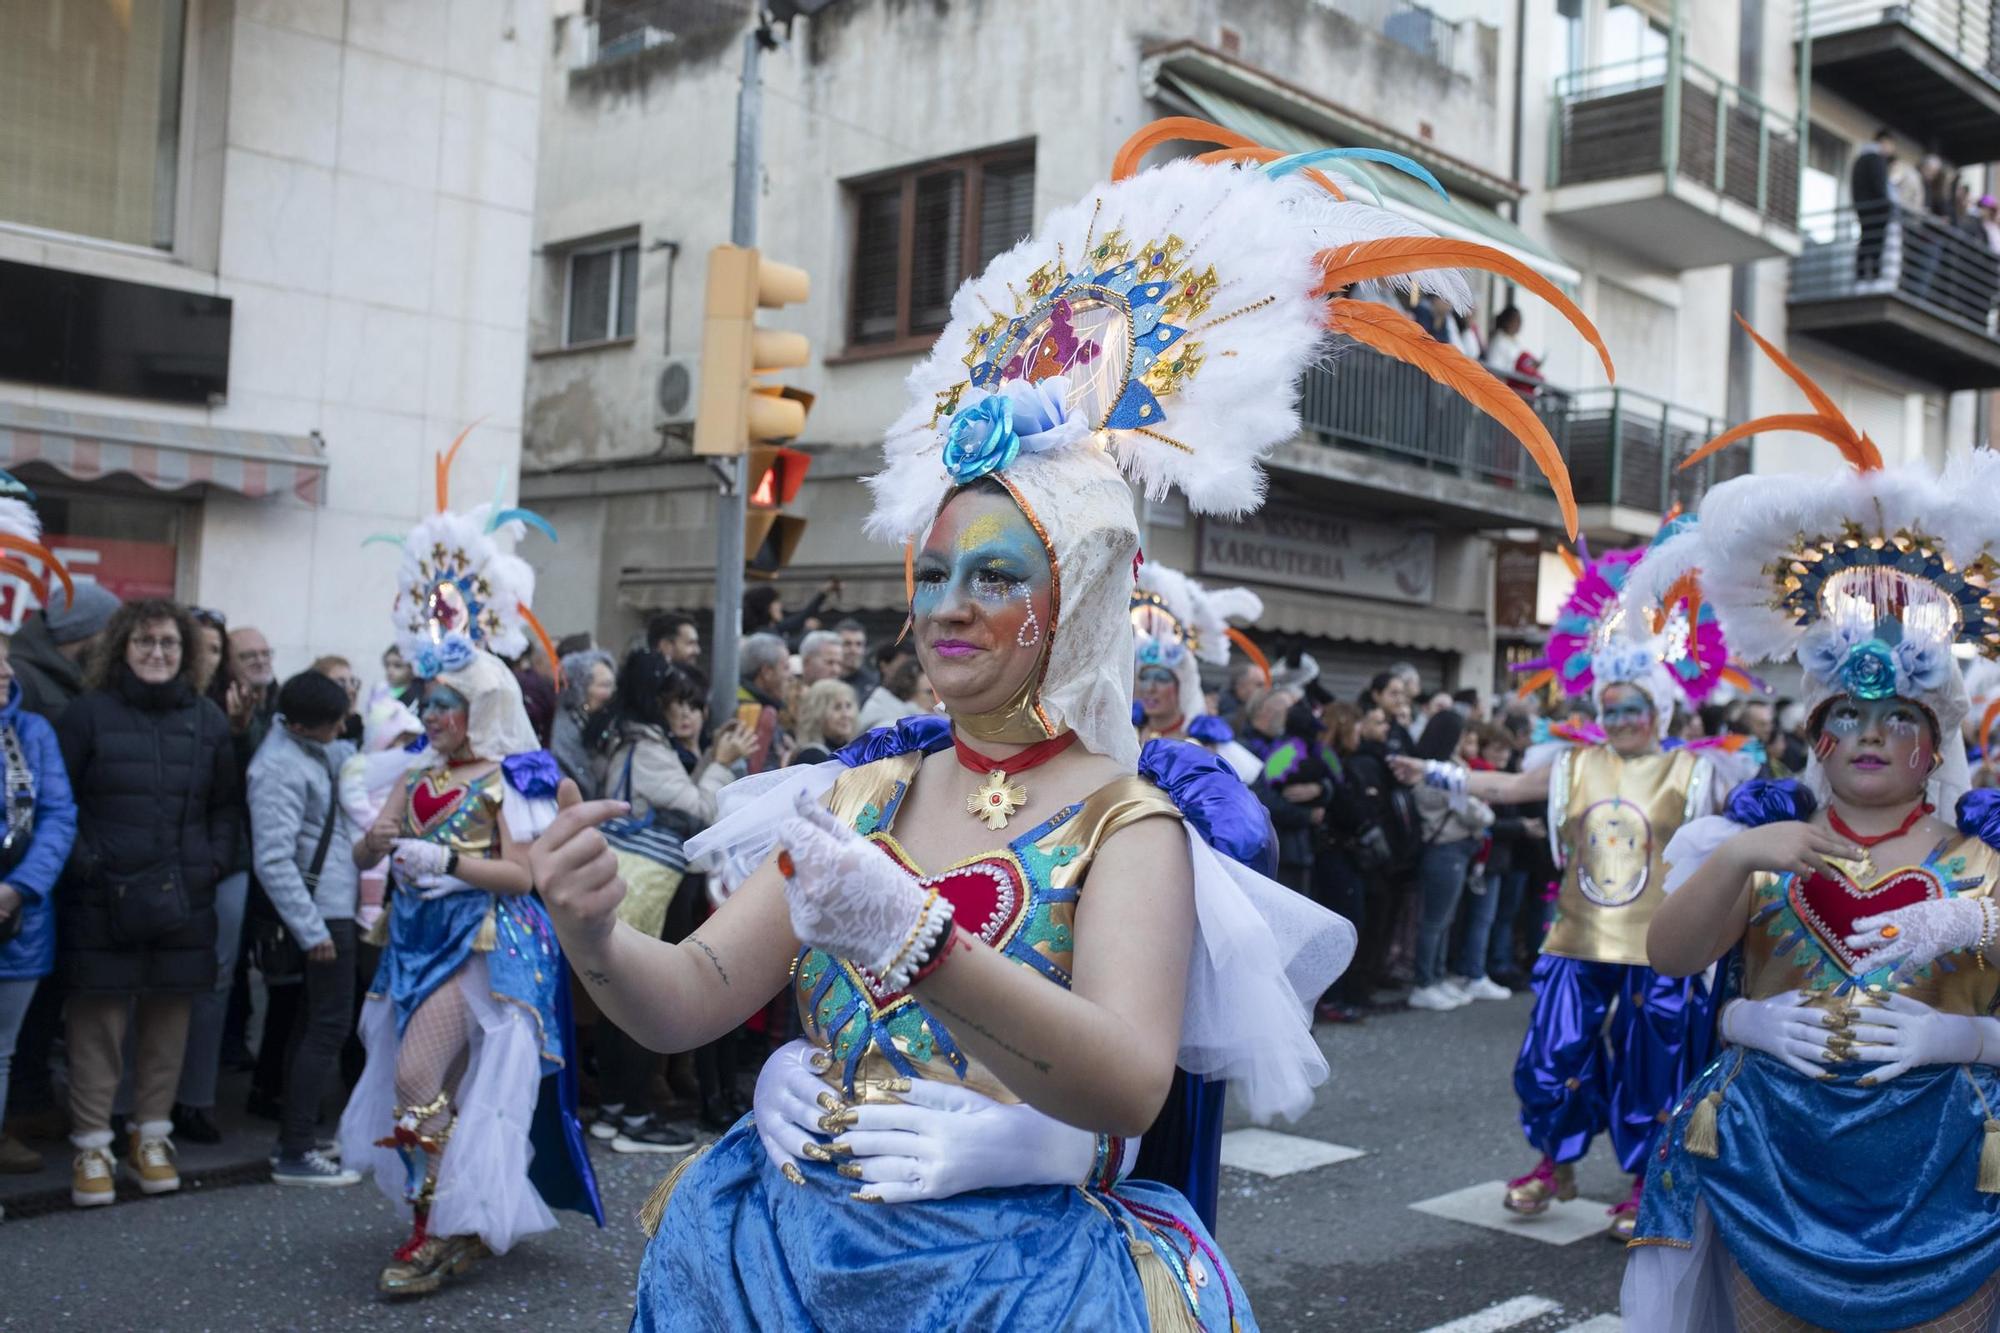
[1548,53,1798,270]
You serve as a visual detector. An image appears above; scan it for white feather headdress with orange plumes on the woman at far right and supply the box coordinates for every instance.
[1628,324,2000,803]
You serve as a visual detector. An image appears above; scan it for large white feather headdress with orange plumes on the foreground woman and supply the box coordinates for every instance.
[868,118,1610,761]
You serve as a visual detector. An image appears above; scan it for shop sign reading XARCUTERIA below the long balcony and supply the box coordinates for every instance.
[1196,504,1438,604]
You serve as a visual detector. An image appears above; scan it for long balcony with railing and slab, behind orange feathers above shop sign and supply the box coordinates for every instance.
[1278,346,1750,540]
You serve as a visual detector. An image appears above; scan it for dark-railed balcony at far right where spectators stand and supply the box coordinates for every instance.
[1788,204,2000,390]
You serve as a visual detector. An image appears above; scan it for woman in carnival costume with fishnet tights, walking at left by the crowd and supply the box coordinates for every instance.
[340,436,604,1297]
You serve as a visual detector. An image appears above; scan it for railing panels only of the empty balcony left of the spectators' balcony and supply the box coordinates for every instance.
[1548,54,1798,228]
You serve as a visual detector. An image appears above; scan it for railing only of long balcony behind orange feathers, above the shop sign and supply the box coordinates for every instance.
[1300,344,1750,512]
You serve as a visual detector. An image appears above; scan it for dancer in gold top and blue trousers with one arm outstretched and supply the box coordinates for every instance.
[1392,510,1750,1241]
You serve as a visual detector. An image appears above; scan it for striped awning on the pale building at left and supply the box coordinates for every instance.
[0,402,326,504]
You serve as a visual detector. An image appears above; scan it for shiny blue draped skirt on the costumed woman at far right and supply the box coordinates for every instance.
[1634,1049,2000,1329]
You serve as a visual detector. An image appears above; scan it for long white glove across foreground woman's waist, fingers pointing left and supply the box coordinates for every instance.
[834,1079,1138,1203]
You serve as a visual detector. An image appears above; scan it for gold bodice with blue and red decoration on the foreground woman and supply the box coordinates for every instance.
[792,753,1180,1103]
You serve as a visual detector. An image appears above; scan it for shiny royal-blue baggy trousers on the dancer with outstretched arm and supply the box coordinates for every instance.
[1514,953,1714,1175]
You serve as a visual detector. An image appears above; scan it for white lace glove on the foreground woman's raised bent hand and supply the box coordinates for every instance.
[778,793,952,991]
